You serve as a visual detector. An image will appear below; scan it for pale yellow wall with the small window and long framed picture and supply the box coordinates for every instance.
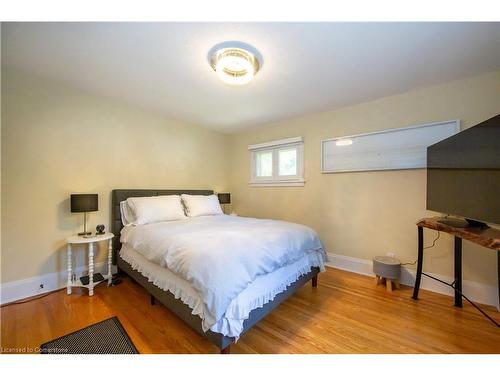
[229,72,500,288]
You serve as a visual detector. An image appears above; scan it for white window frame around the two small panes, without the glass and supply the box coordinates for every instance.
[248,137,305,187]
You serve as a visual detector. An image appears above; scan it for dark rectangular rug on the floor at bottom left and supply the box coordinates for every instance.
[40,316,139,354]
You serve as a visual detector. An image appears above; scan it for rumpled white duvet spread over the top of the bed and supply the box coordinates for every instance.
[121,215,325,330]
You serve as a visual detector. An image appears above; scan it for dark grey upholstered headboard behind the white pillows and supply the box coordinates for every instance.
[111,189,214,264]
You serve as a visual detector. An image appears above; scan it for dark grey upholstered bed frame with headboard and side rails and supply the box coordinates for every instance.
[111,189,319,354]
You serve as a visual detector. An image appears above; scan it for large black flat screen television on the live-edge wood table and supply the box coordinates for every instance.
[427,115,500,226]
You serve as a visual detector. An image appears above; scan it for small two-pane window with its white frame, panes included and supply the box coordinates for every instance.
[248,137,304,186]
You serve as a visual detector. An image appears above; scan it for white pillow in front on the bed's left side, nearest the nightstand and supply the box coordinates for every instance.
[127,195,186,225]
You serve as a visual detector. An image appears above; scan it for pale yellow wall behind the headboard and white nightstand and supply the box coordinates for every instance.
[1,70,228,283]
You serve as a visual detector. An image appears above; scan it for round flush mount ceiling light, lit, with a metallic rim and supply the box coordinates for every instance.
[209,42,260,85]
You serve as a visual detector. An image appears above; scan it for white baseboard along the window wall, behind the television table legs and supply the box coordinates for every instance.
[327,253,500,310]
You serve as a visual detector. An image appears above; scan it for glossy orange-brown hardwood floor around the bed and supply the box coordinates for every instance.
[0,268,500,353]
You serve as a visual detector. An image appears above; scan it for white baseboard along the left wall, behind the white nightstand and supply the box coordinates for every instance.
[0,262,116,305]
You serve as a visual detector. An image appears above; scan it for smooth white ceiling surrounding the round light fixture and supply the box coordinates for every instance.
[2,23,500,132]
